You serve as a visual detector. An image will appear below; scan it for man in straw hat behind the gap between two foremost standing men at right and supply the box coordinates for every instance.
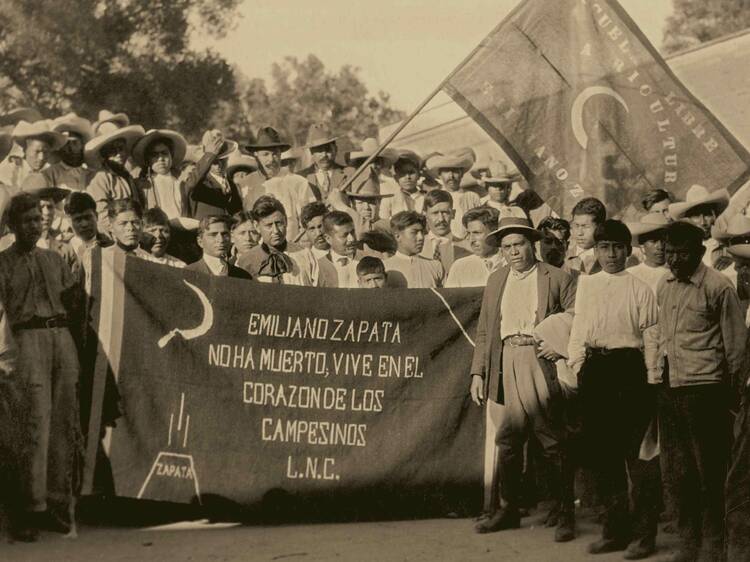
[627,213,670,295]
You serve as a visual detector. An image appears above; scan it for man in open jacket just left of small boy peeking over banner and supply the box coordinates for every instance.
[318,211,359,289]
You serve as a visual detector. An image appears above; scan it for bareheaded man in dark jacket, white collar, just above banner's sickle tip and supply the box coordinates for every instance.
[185,215,252,279]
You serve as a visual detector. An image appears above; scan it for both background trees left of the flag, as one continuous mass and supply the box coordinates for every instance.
[0,0,403,143]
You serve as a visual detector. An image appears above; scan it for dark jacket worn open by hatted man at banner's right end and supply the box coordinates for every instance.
[471,262,576,404]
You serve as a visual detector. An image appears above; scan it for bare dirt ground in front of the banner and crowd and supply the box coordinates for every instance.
[0,506,675,562]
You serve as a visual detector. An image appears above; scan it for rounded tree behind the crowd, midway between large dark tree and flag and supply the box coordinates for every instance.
[228,55,405,145]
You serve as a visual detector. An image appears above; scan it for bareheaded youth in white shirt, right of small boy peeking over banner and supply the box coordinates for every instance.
[384,211,445,289]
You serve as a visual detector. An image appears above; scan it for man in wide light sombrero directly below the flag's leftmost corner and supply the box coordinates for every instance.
[425,148,481,240]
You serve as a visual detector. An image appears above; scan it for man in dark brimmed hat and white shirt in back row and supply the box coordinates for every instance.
[238,127,316,240]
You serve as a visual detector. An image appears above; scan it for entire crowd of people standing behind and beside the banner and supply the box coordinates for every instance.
[0,108,750,561]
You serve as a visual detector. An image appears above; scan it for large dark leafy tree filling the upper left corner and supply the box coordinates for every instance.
[0,0,239,135]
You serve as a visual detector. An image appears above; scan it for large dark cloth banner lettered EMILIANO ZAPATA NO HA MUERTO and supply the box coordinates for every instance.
[89,256,484,506]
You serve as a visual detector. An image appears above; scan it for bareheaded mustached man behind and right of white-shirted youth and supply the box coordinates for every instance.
[421,189,470,272]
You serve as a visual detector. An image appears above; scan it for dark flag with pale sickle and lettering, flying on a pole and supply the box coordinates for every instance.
[444,0,750,215]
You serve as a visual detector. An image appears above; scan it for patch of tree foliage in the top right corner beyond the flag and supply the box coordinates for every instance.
[663,0,750,53]
